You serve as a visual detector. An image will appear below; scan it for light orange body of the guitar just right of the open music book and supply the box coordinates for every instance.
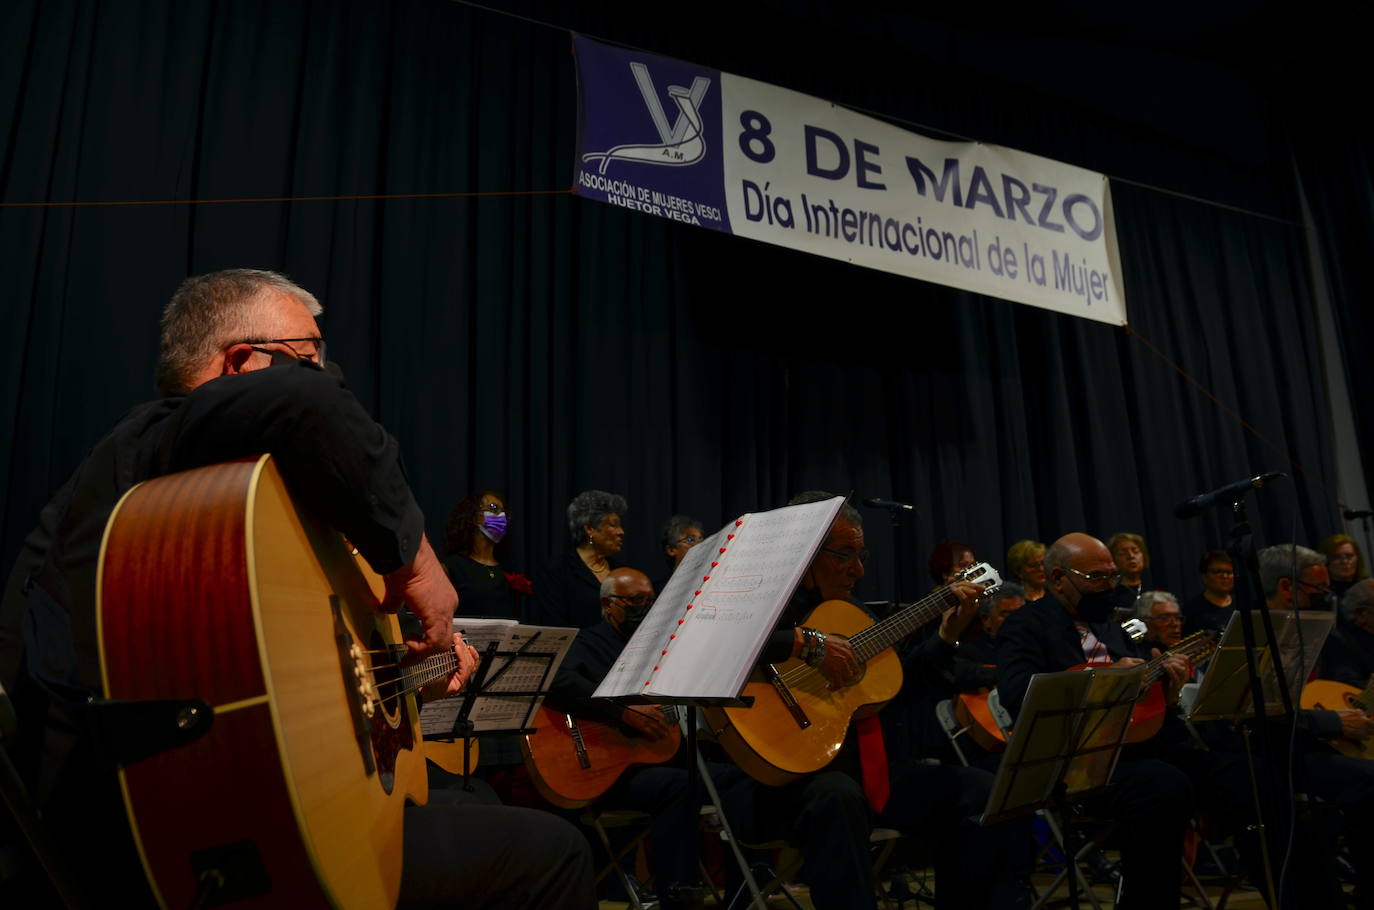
[703,601,901,786]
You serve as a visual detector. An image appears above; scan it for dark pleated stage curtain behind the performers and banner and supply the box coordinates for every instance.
[0,0,1370,613]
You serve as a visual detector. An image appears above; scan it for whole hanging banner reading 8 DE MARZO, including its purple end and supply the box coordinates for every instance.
[576,37,1127,324]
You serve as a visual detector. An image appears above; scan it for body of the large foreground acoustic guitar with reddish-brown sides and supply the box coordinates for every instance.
[98,456,427,907]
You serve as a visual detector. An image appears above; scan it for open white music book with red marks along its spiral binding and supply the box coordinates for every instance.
[595,496,844,701]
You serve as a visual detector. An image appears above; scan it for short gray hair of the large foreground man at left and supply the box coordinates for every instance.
[155,268,324,396]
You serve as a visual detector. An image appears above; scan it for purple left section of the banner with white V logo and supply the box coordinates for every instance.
[573,36,730,232]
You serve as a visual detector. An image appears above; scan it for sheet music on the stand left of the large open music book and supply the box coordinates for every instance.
[420,617,577,735]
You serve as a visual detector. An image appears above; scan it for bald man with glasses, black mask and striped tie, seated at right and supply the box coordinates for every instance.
[998,533,1193,909]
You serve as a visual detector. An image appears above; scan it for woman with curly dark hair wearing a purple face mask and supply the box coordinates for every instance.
[444,489,530,619]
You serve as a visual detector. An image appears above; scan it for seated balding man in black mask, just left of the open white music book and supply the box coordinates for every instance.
[544,568,697,910]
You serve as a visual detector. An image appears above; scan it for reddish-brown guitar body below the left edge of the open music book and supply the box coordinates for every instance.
[521,707,682,808]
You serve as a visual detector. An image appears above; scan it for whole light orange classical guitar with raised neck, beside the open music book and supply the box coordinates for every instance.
[703,562,1002,785]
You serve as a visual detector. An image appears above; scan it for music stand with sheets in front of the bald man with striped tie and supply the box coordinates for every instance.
[978,664,1145,907]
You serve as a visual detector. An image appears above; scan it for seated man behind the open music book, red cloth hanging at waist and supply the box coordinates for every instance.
[723,491,1029,910]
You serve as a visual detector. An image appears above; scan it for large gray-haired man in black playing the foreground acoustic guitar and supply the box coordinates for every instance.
[0,269,595,909]
